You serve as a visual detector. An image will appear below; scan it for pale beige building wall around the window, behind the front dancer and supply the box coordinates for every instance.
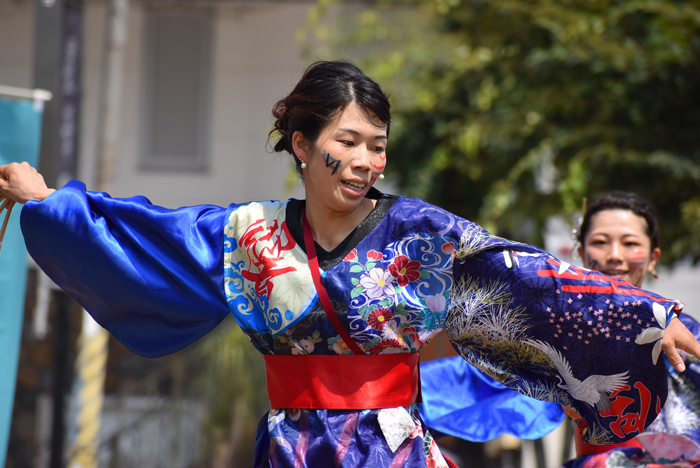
[81,2,309,207]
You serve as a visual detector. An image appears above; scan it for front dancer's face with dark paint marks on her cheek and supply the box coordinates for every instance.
[293,103,387,214]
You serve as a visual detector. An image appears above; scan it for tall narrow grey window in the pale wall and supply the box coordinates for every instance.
[142,9,211,171]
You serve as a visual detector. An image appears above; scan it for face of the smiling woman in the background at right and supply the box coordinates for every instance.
[579,209,661,287]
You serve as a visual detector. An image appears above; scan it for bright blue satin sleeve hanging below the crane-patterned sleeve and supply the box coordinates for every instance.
[418,356,564,442]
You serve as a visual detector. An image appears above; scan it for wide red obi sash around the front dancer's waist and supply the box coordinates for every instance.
[265,353,420,409]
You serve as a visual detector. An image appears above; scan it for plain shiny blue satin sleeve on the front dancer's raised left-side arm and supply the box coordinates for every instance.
[20,181,228,357]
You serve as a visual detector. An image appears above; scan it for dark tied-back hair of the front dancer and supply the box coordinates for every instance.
[268,61,391,174]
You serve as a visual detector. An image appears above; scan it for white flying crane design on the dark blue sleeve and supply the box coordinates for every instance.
[525,340,629,411]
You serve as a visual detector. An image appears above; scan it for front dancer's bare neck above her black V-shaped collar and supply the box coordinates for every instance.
[306,198,377,252]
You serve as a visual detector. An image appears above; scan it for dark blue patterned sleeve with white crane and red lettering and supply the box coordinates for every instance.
[445,231,682,444]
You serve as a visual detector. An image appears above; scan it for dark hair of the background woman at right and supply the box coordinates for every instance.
[578,191,660,250]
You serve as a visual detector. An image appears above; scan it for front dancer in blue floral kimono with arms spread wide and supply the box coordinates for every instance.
[0,62,700,468]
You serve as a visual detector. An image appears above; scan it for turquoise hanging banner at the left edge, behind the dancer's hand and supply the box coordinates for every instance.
[0,99,43,466]
